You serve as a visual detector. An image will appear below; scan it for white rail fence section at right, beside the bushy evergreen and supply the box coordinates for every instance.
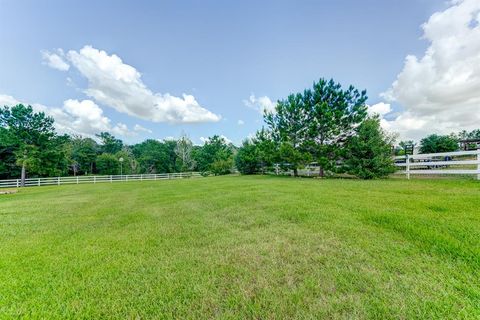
[395,150,480,180]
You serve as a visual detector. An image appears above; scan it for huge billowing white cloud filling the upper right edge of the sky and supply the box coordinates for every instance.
[382,0,480,139]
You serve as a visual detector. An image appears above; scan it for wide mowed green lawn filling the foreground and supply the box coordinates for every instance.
[0,176,480,319]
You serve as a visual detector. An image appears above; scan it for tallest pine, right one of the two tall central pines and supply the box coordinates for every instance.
[303,79,368,176]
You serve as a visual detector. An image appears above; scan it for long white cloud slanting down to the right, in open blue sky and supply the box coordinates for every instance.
[57,46,221,123]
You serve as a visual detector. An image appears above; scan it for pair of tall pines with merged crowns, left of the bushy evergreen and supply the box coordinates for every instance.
[265,79,367,176]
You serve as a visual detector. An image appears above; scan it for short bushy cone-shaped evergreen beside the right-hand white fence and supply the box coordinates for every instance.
[343,117,395,179]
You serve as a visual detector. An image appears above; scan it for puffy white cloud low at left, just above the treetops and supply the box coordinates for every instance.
[0,94,135,137]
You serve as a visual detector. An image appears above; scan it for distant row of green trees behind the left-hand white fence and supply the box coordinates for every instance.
[0,104,236,181]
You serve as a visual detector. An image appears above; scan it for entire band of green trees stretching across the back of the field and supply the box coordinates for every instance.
[0,79,480,181]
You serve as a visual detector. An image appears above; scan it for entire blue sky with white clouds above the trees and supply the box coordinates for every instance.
[0,0,480,144]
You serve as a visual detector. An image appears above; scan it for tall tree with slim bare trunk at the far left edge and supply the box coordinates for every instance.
[0,104,59,186]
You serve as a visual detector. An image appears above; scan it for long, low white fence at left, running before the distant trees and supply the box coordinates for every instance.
[0,172,202,188]
